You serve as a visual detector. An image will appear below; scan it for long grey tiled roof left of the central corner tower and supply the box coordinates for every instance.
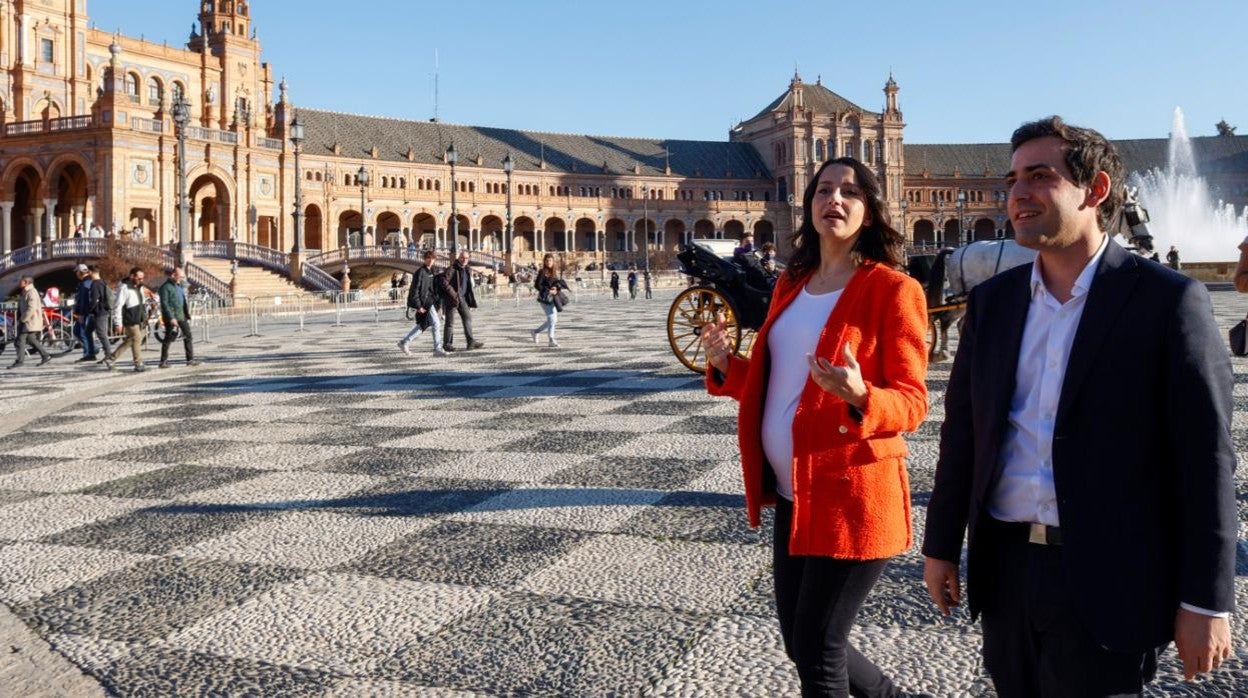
[298,109,771,181]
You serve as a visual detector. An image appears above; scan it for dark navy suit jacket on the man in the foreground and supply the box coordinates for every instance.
[924,241,1237,651]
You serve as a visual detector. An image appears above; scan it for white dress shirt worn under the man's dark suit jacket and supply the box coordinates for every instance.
[988,236,1229,617]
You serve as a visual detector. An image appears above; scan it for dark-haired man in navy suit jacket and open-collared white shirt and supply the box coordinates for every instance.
[924,116,1237,698]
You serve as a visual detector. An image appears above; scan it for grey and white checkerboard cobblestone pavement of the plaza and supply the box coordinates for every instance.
[0,288,1248,696]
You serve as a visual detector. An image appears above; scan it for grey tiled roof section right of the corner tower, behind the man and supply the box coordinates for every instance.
[906,136,1248,177]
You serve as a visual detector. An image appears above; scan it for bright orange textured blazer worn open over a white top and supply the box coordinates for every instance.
[706,262,927,559]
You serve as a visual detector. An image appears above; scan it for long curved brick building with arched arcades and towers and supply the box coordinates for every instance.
[0,0,1248,273]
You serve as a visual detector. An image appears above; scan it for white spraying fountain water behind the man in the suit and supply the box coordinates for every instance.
[1127,107,1248,263]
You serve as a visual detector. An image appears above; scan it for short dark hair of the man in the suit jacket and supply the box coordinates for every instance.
[1010,115,1127,232]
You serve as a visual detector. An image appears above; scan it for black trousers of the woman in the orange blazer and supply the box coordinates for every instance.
[773,498,897,698]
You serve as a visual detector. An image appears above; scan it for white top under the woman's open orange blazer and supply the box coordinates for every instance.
[763,287,844,501]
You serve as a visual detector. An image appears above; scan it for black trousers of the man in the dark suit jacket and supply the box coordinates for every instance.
[971,519,1158,698]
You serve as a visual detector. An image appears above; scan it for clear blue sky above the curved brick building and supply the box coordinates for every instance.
[87,0,1248,142]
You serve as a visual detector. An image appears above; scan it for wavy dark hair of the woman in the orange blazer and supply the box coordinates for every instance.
[785,157,906,280]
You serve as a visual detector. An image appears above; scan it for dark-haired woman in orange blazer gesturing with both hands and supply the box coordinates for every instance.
[703,157,927,696]
